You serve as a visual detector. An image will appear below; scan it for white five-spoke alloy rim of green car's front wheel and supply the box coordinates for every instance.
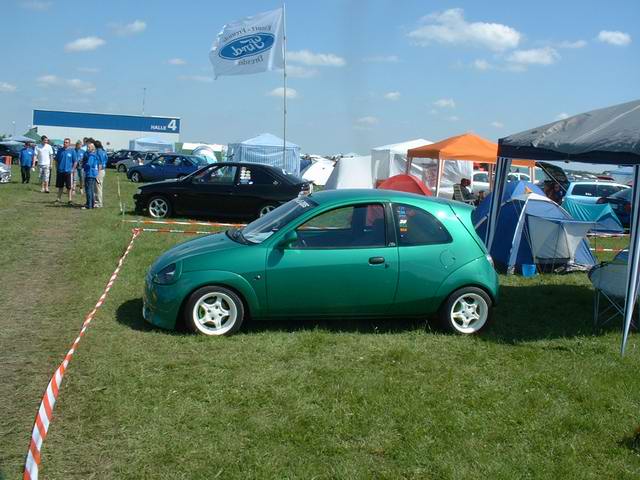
[191,291,238,335]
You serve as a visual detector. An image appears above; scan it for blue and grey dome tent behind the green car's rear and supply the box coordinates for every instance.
[473,182,595,274]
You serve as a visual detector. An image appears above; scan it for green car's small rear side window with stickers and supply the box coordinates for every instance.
[393,203,452,247]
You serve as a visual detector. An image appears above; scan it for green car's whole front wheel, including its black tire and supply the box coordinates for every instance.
[183,285,244,337]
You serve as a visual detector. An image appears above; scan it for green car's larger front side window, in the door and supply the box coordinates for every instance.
[292,203,386,249]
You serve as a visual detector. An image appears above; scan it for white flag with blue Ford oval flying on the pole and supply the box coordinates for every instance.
[209,8,284,78]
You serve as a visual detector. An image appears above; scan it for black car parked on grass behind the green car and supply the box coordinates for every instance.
[133,162,310,218]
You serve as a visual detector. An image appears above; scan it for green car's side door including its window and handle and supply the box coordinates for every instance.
[266,203,398,317]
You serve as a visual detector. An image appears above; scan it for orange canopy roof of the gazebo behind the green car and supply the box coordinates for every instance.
[407,133,536,167]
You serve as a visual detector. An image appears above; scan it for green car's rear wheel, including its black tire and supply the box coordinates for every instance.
[438,287,493,335]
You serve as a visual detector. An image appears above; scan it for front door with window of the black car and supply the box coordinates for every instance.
[176,164,238,217]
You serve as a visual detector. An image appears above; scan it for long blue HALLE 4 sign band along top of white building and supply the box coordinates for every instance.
[33,110,180,133]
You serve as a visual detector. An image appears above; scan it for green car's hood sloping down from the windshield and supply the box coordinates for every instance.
[149,232,246,275]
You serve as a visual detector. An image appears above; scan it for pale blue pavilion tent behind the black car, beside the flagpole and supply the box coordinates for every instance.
[227,133,300,176]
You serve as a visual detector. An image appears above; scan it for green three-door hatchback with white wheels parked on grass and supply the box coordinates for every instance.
[143,190,498,335]
